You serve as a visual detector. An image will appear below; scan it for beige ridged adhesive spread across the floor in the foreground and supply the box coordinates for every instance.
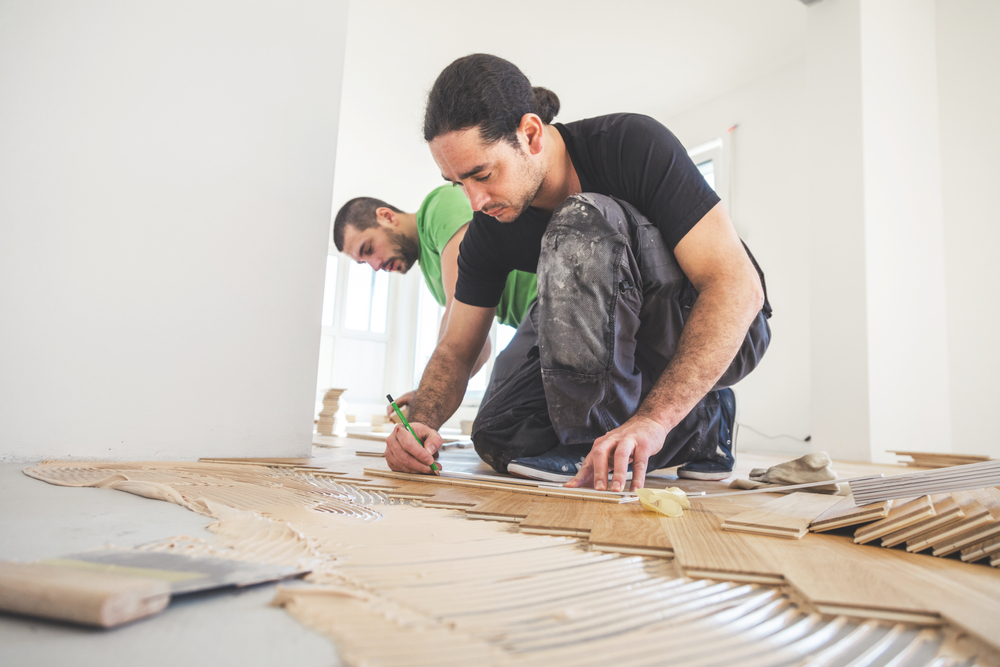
[19,461,995,666]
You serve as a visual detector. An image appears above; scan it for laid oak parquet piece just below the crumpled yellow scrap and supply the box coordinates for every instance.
[590,503,674,557]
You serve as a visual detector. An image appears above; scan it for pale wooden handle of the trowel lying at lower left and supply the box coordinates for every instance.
[0,562,170,628]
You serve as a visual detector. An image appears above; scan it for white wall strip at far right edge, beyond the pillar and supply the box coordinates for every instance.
[937,0,1000,457]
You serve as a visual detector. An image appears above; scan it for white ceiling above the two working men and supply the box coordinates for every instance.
[333,0,808,218]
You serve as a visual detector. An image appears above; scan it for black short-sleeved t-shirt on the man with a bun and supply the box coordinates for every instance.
[455,114,719,308]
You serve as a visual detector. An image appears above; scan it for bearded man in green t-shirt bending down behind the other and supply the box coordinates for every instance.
[333,185,538,405]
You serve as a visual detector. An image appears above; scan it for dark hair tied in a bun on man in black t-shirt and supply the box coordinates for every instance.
[424,53,559,145]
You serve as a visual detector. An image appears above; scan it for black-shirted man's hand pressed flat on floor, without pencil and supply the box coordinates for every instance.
[566,415,667,491]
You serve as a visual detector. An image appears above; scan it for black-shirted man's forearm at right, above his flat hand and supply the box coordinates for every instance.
[636,281,764,430]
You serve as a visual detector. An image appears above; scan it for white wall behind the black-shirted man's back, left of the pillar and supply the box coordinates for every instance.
[661,60,811,454]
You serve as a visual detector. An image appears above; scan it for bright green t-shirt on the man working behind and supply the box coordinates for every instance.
[417,185,538,327]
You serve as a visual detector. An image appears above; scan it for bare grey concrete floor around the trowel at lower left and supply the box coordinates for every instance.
[0,463,340,667]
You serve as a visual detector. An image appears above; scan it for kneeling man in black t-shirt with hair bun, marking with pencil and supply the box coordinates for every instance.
[386,54,770,491]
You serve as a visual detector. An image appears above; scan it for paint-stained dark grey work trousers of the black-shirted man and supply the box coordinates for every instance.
[472,193,771,472]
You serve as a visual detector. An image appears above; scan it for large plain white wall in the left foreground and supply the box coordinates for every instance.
[0,0,347,460]
